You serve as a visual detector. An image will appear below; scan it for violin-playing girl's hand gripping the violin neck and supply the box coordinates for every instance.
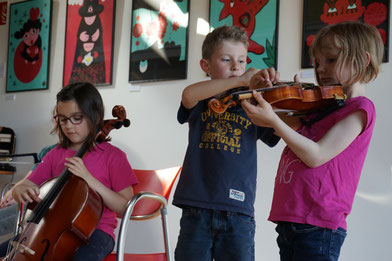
[241,91,279,127]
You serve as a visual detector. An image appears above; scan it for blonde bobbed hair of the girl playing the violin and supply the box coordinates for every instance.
[310,22,384,85]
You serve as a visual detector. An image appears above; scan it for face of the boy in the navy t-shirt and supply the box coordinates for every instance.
[200,41,248,79]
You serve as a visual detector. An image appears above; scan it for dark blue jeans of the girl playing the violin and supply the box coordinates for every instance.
[276,222,347,261]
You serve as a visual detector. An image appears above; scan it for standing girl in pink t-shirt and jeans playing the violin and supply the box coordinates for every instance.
[242,22,384,261]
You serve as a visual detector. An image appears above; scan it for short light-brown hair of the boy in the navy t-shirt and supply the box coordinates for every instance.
[201,25,249,60]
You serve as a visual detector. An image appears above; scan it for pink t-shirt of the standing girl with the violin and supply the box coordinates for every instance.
[268,96,376,229]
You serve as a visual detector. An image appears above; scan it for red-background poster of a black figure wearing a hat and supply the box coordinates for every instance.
[63,0,116,86]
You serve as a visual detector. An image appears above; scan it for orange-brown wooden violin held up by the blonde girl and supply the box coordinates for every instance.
[208,82,347,114]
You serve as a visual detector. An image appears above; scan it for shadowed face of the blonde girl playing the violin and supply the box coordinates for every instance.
[314,47,351,86]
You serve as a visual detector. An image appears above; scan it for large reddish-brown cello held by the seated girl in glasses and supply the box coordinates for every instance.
[3,105,130,261]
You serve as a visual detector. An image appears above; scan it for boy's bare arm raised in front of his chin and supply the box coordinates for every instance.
[181,68,259,109]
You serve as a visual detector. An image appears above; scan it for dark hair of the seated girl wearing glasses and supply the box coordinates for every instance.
[56,82,105,148]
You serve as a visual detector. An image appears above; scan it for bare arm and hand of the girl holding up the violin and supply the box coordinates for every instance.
[242,92,366,168]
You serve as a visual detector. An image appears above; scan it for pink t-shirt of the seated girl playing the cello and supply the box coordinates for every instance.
[28,142,137,238]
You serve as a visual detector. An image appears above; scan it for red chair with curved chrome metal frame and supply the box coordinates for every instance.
[105,166,181,261]
